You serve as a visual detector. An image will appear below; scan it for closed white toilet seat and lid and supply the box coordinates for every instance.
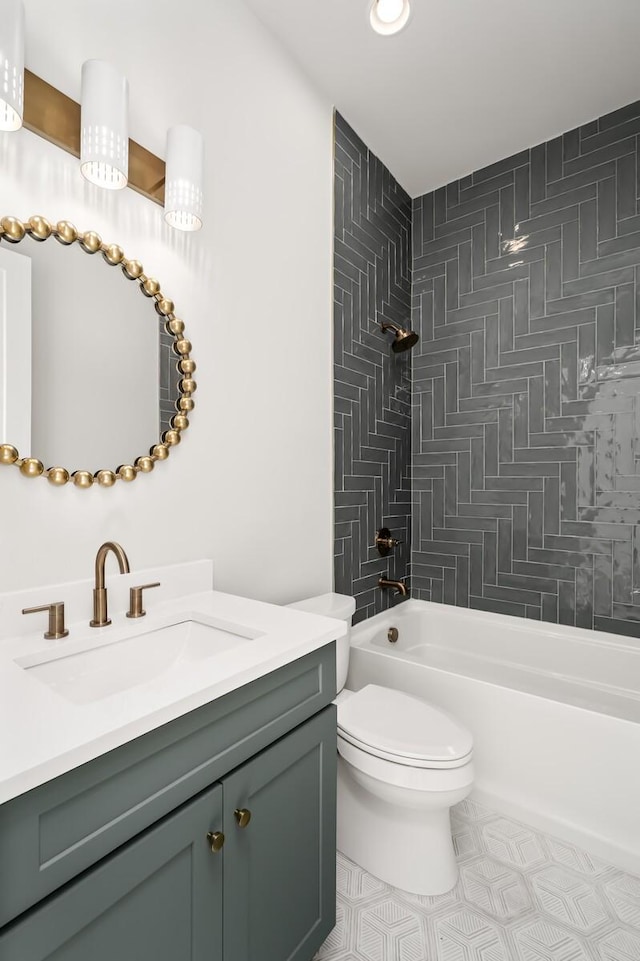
[338,684,473,769]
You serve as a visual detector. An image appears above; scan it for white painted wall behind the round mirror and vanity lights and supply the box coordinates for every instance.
[0,0,332,601]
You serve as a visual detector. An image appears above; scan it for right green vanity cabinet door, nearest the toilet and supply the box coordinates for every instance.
[222,705,336,961]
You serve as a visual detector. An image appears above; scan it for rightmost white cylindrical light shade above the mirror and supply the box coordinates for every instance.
[164,124,204,230]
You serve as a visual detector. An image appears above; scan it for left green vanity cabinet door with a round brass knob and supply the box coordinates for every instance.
[0,784,224,961]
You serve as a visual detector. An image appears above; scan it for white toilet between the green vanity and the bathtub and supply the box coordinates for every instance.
[289,594,473,895]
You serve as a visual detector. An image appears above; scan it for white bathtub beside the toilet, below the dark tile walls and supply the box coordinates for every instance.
[347,600,640,874]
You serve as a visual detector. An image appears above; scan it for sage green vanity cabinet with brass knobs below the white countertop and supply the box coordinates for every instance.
[0,644,336,961]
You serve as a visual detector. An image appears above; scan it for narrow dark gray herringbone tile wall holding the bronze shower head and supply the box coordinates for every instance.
[334,114,411,622]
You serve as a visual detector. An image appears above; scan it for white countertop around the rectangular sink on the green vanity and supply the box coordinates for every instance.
[0,591,346,803]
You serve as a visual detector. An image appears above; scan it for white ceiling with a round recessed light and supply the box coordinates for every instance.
[246,0,640,197]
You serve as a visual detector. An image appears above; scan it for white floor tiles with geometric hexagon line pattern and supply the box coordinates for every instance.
[316,800,640,961]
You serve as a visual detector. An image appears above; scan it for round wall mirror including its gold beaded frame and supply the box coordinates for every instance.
[0,217,196,487]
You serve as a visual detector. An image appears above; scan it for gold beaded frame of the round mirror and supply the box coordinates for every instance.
[0,216,196,488]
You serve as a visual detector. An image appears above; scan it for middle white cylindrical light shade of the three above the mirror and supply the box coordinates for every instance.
[80,60,129,190]
